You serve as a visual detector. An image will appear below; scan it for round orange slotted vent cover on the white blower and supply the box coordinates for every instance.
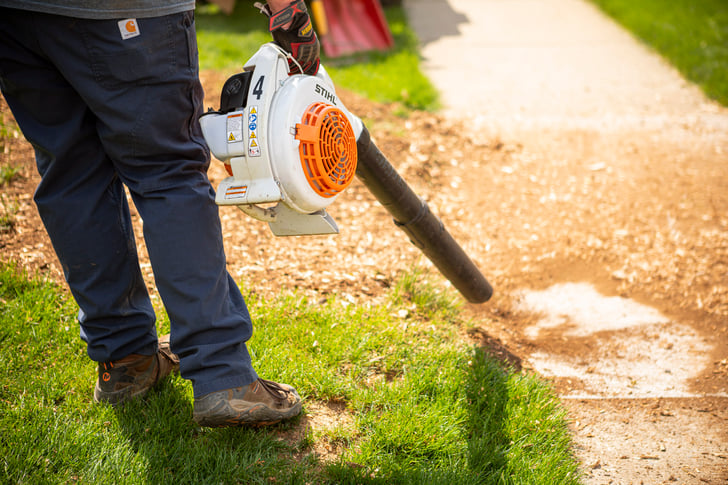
[296,102,357,198]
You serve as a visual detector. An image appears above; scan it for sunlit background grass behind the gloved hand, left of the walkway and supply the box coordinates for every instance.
[196,3,439,110]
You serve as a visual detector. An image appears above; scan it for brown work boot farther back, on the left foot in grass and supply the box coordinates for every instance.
[94,335,179,406]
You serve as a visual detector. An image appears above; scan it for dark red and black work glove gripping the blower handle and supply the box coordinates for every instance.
[255,0,320,76]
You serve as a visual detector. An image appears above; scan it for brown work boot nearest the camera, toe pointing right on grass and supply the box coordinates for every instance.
[192,379,301,428]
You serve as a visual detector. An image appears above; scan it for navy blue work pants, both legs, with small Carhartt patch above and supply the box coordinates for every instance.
[0,8,257,396]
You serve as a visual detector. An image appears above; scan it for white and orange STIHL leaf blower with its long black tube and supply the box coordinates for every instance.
[200,43,493,303]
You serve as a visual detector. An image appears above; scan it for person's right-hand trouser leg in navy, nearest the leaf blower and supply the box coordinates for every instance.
[33,12,257,396]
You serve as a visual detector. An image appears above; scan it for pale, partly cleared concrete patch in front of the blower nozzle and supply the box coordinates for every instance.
[518,283,712,398]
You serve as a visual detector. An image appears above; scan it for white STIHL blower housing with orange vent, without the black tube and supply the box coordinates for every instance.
[200,43,362,236]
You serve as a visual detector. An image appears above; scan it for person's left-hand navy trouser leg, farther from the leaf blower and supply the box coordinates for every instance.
[0,9,157,362]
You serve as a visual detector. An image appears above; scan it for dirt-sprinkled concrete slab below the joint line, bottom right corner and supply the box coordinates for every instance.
[564,398,728,484]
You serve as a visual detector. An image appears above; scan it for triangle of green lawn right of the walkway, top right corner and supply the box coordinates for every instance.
[593,0,728,106]
